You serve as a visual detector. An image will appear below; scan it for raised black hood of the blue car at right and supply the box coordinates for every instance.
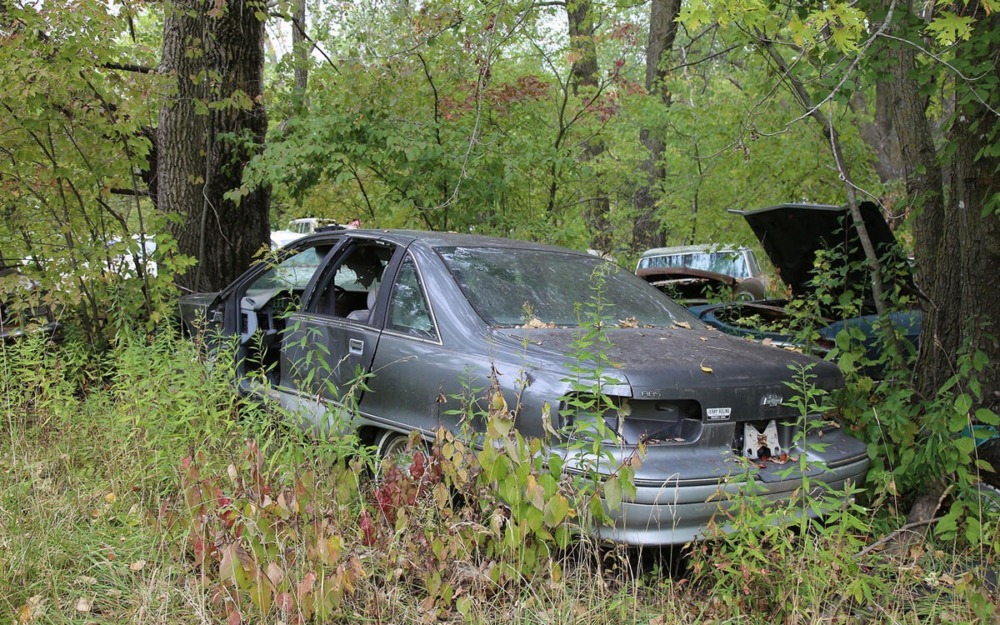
[729,202,916,296]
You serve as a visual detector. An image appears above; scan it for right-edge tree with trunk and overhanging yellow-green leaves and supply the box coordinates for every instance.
[685,0,1000,521]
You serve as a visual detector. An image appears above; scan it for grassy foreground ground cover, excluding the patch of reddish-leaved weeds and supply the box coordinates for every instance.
[0,338,1000,625]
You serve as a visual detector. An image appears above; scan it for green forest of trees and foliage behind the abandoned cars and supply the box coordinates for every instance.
[0,0,1000,614]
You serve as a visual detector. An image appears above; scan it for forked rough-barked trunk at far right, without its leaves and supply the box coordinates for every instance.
[887,2,1000,522]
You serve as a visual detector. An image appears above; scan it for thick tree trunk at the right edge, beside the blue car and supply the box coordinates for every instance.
[872,1,1000,522]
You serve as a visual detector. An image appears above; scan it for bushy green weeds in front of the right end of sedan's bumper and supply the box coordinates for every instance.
[691,369,887,622]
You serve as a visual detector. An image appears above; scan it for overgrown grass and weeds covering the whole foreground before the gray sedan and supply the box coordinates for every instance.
[0,333,997,624]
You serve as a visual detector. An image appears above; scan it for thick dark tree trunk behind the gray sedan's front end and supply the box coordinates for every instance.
[157,0,270,291]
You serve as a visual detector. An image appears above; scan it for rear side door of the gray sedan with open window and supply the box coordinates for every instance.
[279,237,399,431]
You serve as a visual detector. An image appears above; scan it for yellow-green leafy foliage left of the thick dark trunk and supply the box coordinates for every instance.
[0,3,176,344]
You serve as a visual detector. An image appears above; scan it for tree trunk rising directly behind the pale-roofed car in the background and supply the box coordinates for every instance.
[632,0,681,251]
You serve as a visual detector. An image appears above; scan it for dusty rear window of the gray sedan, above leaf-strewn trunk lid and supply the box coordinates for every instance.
[438,247,697,327]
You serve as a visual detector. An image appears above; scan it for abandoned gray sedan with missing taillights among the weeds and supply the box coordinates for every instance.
[181,230,868,544]
